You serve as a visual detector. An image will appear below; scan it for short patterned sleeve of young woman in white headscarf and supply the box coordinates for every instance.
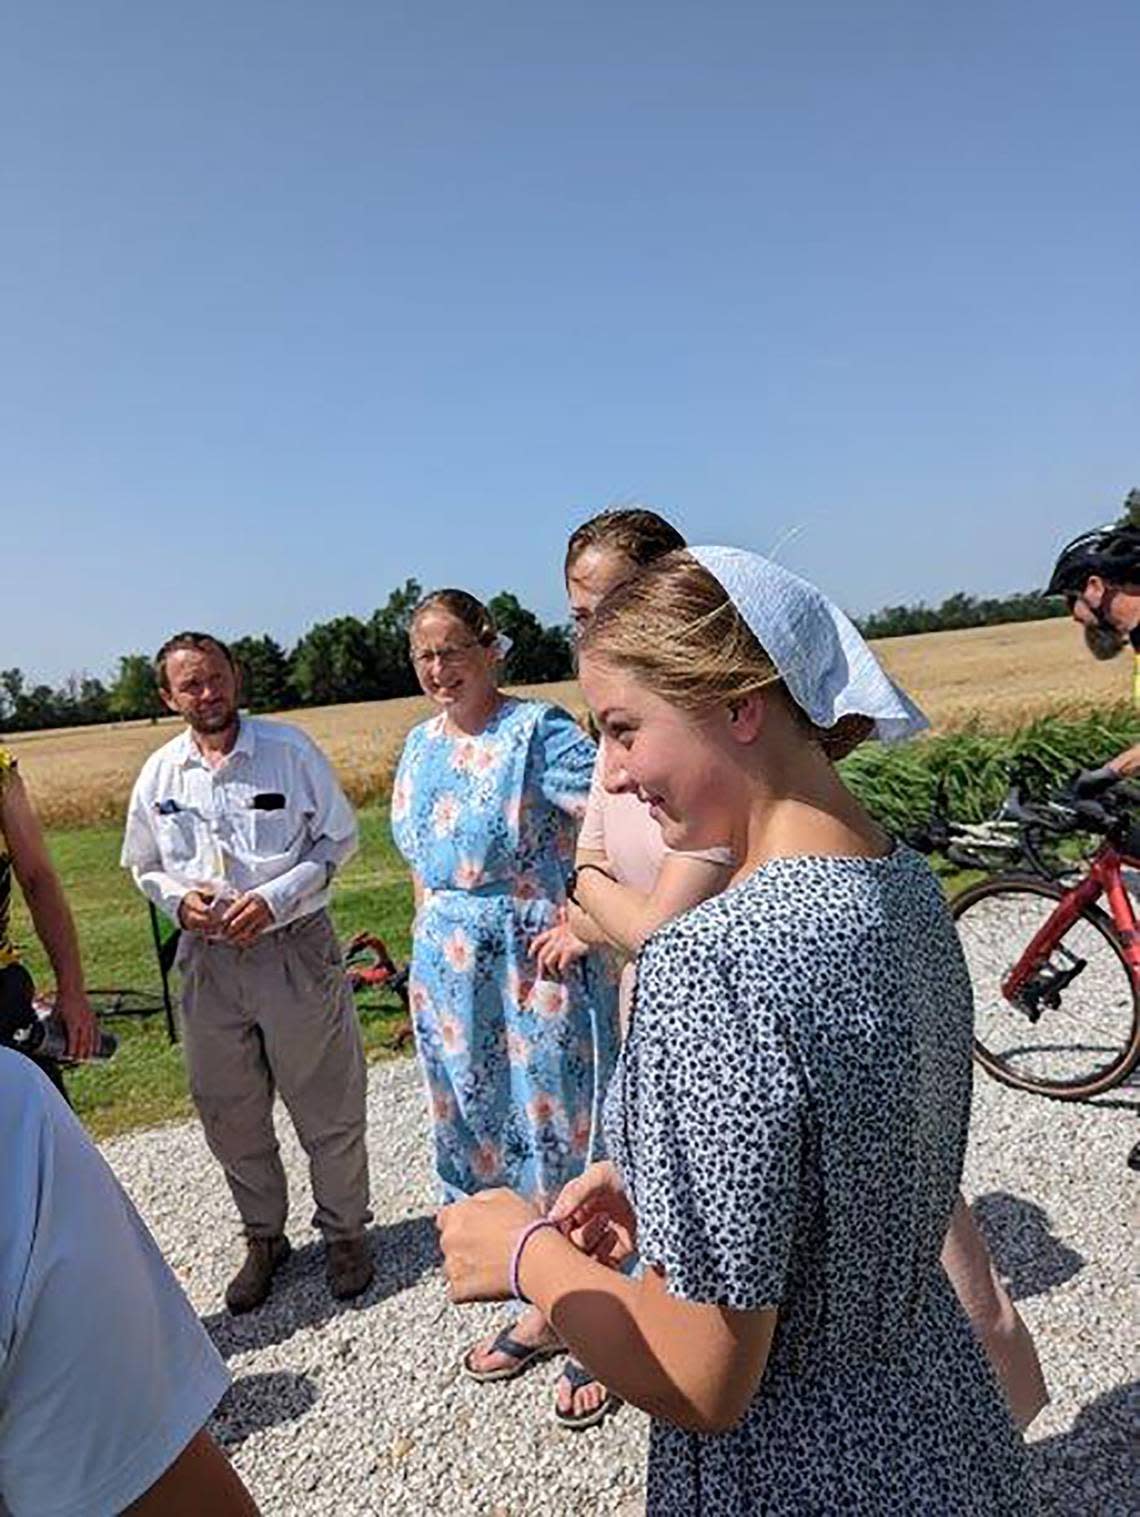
[630,922,808,1311]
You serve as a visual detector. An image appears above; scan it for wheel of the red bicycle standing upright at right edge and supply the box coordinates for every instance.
[950,875,1140,1101]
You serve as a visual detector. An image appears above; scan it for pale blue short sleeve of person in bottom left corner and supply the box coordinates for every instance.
[0,1050,229,1517]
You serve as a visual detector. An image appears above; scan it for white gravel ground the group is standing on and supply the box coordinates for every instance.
[105,1060,1140,1517]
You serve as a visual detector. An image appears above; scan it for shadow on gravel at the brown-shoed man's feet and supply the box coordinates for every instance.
[202,1217,440,1359]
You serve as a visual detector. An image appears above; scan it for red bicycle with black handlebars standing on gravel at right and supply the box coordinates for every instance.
[950,784,1140,1101]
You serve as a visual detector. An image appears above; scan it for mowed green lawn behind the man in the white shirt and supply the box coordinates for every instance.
[14,806,413,1138]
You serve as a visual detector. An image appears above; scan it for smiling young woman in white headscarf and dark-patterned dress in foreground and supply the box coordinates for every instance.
[440,548,1035,1517]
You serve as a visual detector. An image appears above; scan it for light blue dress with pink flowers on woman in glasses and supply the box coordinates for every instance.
[392,699,618,1200]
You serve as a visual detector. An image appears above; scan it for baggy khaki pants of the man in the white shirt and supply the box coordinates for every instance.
[178,912,372,1239]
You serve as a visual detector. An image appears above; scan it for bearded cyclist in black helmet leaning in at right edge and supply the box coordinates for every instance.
[1044,523,1140,789]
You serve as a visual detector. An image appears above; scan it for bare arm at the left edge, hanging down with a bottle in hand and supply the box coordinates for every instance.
[0,774,97,1059]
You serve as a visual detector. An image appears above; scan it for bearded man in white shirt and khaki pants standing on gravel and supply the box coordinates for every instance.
[121,633,372,1312]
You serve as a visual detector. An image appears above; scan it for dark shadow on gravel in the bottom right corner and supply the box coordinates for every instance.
[1029,1380,1140,1517]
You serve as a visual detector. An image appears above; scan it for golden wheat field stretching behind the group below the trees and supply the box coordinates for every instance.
[5,619,1132,827]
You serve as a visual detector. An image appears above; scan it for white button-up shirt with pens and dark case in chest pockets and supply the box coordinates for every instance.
[121,716,357,927]
